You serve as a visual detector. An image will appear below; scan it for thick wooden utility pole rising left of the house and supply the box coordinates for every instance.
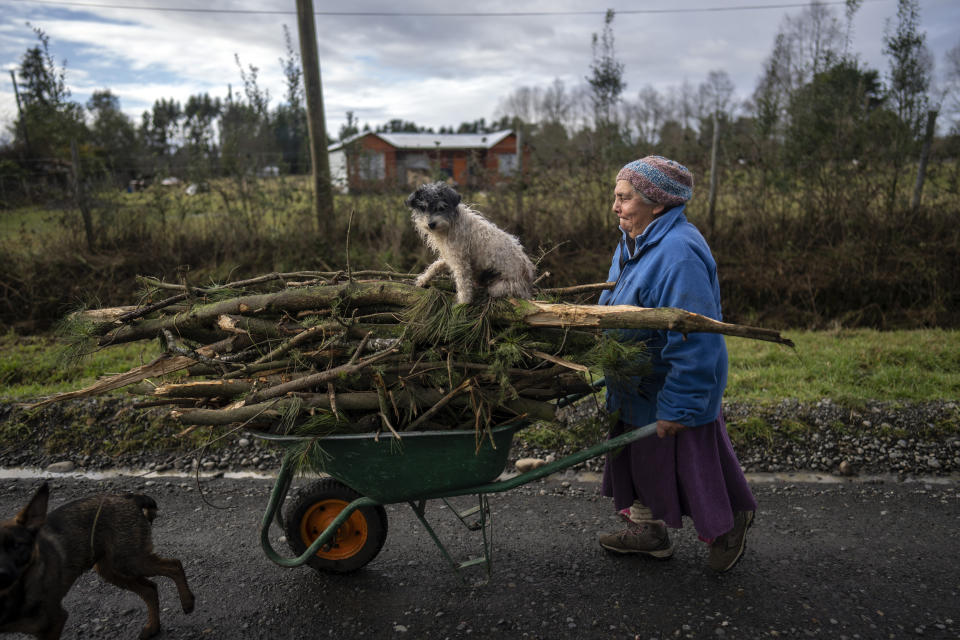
[297,0,333,240]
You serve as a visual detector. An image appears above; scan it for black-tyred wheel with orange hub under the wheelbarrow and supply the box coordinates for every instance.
[284,478,387,573]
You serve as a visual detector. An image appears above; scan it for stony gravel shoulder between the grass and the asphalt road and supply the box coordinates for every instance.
[0,398,960,479]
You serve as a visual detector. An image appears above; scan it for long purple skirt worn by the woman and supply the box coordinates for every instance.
[601,415,757,540]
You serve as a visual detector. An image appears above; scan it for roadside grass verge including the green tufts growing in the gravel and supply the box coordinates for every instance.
[0,330,960,455]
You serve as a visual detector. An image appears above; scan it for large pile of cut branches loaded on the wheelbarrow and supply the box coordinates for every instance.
[35,271,789,437]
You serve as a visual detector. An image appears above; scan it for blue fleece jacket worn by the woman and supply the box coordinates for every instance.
[600,205,727,427]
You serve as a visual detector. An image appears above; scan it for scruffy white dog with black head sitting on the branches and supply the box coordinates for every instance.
[406,182,534,303]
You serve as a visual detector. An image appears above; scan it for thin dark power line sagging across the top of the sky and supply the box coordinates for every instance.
[11,0,892,18]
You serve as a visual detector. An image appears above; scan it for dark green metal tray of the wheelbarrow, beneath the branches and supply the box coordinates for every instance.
[255,421,527,504]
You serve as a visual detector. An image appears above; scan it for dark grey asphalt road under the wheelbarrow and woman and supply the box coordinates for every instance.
[0,477,960,640]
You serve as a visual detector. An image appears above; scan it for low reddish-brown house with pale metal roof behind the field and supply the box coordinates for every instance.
[328,129,528,191]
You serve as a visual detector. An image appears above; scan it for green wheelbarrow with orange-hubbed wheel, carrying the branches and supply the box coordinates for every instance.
[259,388,656,573]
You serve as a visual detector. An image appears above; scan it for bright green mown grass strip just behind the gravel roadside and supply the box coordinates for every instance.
[0,329,960,404]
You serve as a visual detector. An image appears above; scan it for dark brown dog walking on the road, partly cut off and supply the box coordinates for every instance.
[0,483,194,640]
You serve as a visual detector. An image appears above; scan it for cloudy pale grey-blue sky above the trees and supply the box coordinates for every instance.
[0,0,960,144]
